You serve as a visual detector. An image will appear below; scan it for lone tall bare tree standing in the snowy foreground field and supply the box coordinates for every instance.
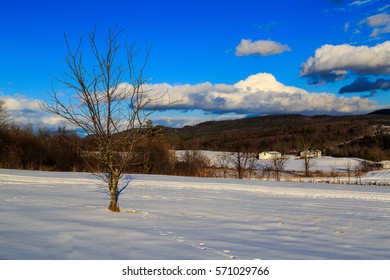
[41,28,170,212]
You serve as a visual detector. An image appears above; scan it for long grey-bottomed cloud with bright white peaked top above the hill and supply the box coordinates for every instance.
[147,73,376,115]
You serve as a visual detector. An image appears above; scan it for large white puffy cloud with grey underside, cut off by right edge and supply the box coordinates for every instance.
[300,41,390,84]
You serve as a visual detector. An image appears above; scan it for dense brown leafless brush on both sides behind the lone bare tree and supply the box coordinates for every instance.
[0,118,201,176]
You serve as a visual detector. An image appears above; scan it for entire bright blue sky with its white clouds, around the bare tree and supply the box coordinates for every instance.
[0,0,390,126]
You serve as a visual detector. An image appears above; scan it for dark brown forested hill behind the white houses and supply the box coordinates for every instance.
[163,110,390,160]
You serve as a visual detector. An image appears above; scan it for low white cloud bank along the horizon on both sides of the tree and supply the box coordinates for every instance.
[3,73,377,128]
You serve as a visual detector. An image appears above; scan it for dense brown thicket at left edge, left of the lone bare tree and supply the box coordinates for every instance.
[0,124,86,171]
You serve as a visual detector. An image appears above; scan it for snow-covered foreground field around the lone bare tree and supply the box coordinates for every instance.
[0,167,390,260]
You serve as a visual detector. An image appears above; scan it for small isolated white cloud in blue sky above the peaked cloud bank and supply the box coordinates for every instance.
[236,39,291,56]
